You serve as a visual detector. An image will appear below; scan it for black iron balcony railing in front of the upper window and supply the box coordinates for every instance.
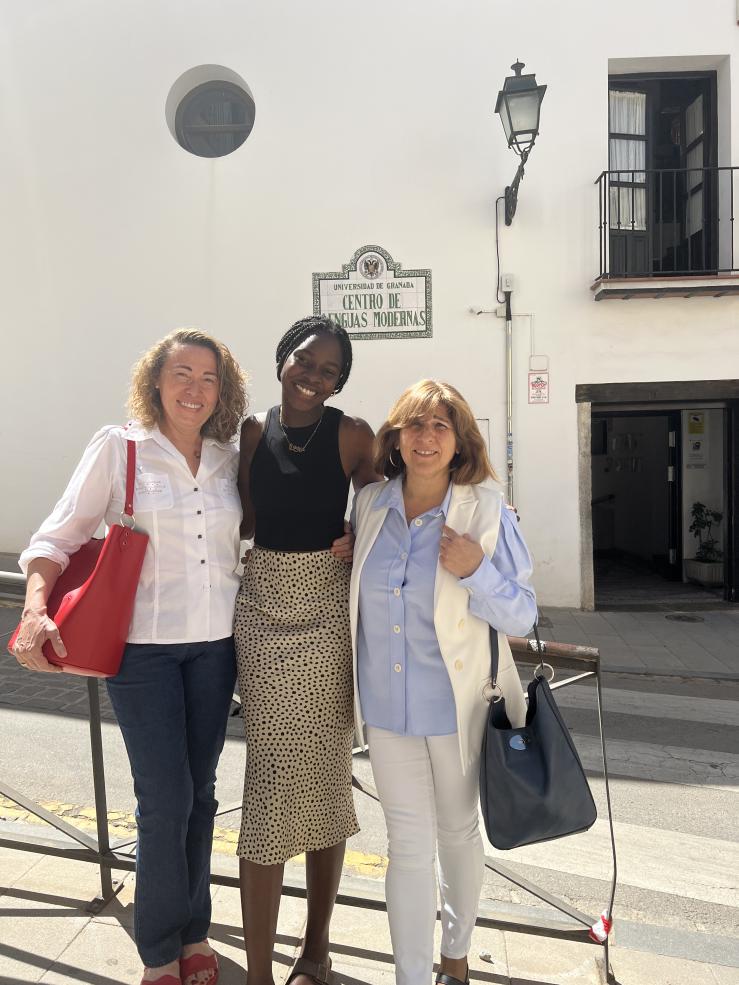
[595,167,739,278]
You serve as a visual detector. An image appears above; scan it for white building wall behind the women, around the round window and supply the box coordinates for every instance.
[0,0,739,605]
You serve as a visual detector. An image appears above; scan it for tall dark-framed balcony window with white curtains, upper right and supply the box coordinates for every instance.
[602,72,716,277]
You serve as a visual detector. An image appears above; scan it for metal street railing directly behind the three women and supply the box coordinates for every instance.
[0,579,617,981]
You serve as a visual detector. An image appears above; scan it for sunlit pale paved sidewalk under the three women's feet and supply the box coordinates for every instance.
[0,836,739,985]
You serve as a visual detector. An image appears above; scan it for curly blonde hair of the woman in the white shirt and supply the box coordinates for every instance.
[128,328,247,441]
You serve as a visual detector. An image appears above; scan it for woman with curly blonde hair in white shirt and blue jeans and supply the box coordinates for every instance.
[15,328,246,985]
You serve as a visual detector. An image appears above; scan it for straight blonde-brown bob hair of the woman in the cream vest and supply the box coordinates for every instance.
[375,380,498,486]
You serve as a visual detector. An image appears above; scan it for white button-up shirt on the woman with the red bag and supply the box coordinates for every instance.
[20,423,241,643]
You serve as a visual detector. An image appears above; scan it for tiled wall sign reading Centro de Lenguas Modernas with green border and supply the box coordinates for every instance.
[313,246,431,339]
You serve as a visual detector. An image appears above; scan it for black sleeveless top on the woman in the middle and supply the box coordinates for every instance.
[249,407,349,551]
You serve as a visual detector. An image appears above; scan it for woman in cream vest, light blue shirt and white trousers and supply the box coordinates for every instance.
[350,380,536,985]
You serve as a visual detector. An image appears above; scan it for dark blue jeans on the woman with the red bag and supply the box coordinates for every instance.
[107,637,236,967]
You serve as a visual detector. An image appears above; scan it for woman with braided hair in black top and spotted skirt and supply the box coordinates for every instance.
[234,317,378,985]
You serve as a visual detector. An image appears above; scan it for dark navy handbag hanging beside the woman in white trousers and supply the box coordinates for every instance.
[480,626,597,849]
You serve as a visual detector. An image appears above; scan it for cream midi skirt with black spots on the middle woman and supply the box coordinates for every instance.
[234,547,359,865]
